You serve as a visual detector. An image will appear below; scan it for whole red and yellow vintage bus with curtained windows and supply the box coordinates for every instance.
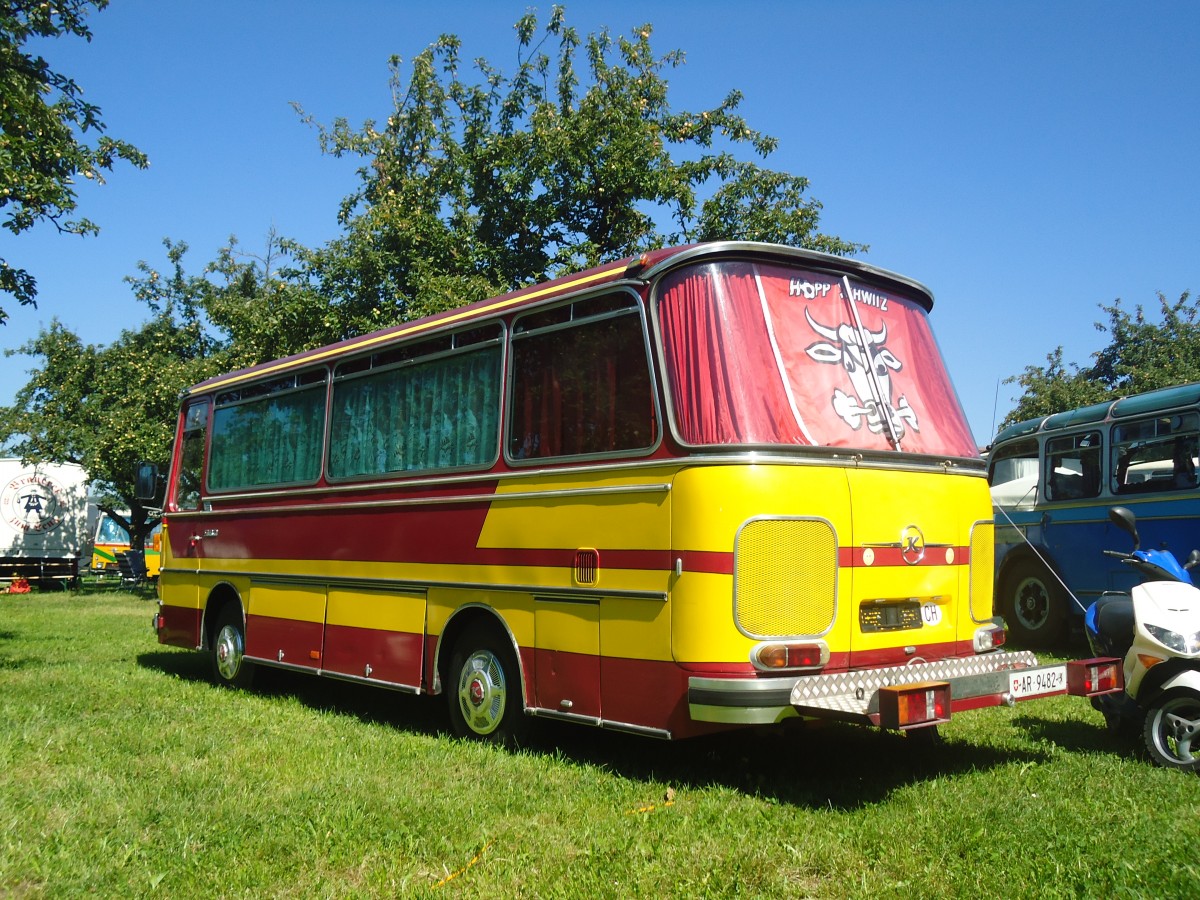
[142,242,1120,743]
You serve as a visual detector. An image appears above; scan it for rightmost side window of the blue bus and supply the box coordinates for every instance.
[1112,414,1200,493]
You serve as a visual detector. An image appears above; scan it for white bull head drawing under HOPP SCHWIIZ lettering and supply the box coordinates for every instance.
[804,310,920,442]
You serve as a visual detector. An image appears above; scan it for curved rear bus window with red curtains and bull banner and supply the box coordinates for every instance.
[658,262,978,457]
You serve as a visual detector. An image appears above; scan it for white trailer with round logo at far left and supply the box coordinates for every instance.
[0,457,88,588]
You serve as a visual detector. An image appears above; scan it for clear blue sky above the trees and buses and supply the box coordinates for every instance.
[0,0,1200,444]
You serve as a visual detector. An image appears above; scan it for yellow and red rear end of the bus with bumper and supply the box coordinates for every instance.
[654,247,1111,728]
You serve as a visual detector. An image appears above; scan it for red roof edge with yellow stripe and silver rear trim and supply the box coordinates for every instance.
[184,241,934,397]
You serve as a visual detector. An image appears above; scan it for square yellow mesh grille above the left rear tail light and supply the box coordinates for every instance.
[733,518,838,638]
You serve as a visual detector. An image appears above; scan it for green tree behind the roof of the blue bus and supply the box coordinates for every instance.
[1002,292,1200,426]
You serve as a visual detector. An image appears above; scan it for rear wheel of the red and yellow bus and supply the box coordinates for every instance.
[446,625,529,746]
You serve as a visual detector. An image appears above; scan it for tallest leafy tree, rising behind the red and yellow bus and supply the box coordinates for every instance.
[296,6,865,337]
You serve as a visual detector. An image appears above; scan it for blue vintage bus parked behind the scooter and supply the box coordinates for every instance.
[988,384,1200,646]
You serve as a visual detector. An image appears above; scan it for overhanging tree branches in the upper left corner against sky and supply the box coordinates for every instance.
[0,0,146,323]
